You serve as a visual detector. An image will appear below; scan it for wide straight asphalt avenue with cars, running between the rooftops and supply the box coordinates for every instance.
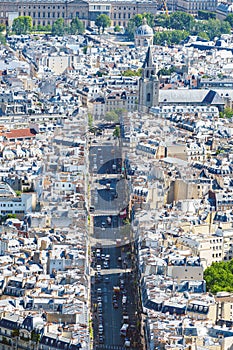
[90,139,138,350]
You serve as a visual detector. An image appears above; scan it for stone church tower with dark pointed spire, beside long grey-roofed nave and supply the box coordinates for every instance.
[138,46,159,113]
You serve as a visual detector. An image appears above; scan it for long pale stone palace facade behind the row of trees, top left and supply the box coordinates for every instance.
[0,0,157,27]
